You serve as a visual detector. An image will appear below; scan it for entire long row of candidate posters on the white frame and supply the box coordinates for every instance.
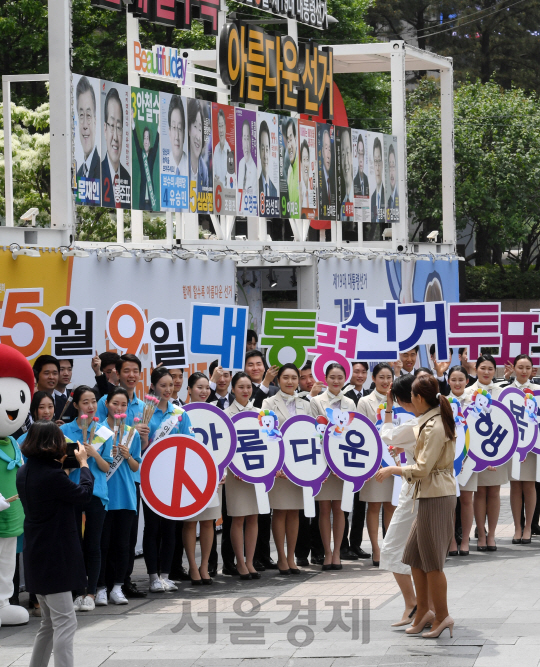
[72,74,399,224]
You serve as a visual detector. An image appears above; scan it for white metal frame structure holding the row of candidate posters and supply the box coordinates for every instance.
[0,5,456,266]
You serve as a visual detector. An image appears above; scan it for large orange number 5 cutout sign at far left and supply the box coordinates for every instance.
[0,287,49,359]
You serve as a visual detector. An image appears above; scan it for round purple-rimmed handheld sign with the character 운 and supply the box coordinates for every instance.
[323,408,383,512]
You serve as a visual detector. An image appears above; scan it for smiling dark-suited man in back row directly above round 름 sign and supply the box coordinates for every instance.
[244,350,279,572]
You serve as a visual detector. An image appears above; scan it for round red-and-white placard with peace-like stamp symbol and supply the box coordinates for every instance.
[141,435,219,521]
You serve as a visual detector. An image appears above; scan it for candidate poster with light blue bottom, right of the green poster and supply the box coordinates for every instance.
[159,93,189,211]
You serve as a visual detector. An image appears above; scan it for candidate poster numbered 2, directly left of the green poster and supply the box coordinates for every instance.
[101,80,131,208]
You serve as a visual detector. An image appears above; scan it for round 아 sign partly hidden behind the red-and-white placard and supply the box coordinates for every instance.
[184,403,236,479]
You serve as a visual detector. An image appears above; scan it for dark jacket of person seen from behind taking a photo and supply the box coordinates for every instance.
[17,457,94,595]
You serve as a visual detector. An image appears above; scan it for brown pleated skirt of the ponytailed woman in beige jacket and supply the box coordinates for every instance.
[400,496,456,572]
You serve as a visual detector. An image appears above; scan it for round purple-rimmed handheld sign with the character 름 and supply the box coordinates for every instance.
[229,410,285,514]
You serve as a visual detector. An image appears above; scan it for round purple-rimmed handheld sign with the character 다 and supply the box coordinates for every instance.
[281,415,330,517]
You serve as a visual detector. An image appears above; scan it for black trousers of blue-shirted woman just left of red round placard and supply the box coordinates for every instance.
[98,510,136,588]
